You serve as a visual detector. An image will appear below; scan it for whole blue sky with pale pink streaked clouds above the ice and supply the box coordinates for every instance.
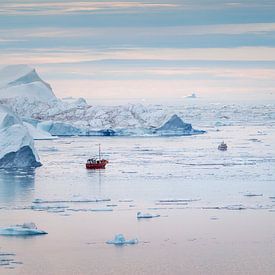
[0,0,275,99]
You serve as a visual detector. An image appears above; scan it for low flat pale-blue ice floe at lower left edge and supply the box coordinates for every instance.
[0,222,48,236]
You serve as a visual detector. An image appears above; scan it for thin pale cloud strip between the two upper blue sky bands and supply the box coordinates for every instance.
[0,23,275,40]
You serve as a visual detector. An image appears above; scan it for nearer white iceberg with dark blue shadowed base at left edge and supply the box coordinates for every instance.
[0,105,41,168]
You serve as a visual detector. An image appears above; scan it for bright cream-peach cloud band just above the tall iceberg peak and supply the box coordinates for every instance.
[0,47,275,64]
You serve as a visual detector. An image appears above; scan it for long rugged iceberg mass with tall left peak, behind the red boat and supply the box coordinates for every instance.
[0,65,204,136]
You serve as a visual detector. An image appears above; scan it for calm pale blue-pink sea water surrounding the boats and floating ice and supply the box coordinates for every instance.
[0,106,275,274]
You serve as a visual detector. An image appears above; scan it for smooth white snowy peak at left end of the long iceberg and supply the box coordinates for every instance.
[0,65,56,102]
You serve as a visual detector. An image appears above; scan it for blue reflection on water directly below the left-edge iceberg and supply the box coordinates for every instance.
[0,169,35,206]
